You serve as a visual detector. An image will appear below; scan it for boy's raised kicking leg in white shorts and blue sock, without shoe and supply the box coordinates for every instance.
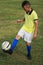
[10,29,24,51]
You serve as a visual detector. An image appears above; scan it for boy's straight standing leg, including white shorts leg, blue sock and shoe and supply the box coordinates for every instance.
[24,32,33,59]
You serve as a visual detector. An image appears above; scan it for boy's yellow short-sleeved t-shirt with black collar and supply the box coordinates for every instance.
[22,10,38,33]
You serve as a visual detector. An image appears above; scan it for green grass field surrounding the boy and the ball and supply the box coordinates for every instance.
[0,0,43,65]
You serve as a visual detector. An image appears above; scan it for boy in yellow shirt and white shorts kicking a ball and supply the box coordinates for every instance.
[5,1,38,59]
